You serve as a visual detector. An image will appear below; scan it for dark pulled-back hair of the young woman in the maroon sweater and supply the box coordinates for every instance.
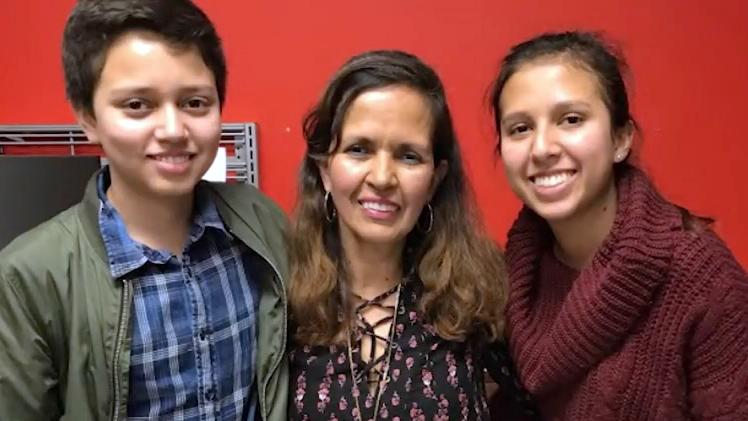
[490,31,637,160]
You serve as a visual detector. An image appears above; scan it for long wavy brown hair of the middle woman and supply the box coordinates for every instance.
[289,50,506,345]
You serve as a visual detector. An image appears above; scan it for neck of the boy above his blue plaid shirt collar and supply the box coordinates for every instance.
[106,174,194,256]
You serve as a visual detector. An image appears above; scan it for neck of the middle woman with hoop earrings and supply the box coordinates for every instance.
[343,236,404,299]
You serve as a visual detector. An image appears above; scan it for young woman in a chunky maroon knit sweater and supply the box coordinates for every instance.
[492,32,748,421]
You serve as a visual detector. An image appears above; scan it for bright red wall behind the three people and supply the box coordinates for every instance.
[0,0,748,266]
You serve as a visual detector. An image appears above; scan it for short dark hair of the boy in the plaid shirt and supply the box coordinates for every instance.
[62,0,226,116]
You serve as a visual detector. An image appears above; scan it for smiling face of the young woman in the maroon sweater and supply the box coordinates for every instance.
[499,58,631,223]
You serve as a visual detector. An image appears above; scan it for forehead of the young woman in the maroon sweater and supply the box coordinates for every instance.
[499,58,604,114]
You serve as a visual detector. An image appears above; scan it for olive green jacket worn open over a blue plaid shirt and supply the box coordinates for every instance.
[0,172,288,421]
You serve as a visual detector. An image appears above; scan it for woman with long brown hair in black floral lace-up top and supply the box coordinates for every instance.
[289,51,536,421]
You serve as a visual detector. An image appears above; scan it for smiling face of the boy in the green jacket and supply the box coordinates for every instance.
[79,31,221,198]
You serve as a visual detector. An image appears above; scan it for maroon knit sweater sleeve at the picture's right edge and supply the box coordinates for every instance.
[686,243,748,421]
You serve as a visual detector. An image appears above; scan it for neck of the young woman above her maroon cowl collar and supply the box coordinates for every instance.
[549,181,617,269]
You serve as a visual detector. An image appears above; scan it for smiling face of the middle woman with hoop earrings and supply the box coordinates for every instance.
[320,85,446,251]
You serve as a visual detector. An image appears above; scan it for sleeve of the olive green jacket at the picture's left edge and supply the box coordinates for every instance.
[0,262,61,421]
